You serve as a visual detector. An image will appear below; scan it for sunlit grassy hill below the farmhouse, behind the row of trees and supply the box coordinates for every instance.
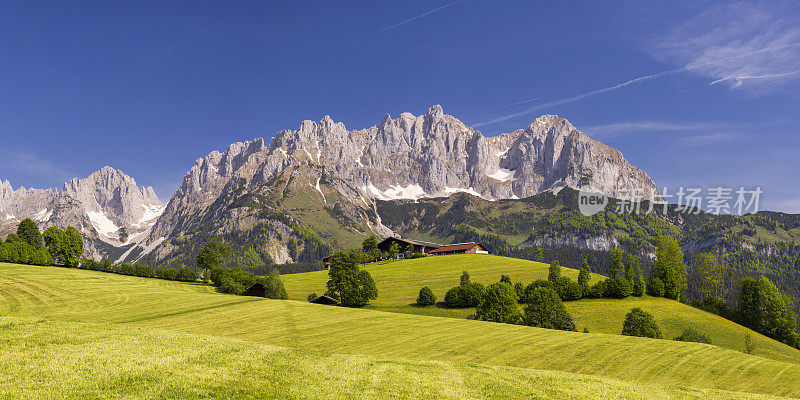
[283,254,800,362]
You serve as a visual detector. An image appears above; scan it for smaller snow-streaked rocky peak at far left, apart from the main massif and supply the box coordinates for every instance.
[0,167,164,258]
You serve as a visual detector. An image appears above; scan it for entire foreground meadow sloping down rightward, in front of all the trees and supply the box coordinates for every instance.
[0,257,800,398]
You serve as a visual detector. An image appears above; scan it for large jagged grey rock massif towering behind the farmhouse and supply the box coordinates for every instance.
[132,105,656,266]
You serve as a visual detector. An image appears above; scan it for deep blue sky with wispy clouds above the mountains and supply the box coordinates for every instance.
[0,0,800,212]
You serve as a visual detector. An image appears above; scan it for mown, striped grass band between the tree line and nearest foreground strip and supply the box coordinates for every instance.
[0,264,800,396]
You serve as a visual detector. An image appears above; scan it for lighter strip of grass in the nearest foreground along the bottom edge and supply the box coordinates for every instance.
[0,318,788,400]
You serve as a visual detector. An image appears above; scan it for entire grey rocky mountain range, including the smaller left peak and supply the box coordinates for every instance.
[0,105,657,264]
